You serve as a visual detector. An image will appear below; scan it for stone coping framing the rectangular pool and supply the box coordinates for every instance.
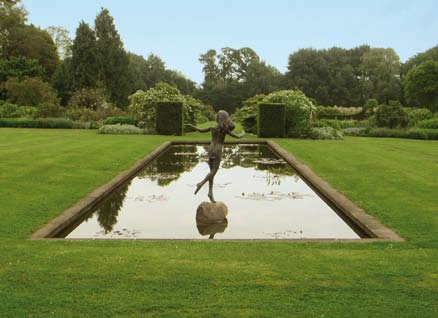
[30,140,404,242]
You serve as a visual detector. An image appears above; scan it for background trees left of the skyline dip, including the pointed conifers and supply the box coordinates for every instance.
[0,0,196,109]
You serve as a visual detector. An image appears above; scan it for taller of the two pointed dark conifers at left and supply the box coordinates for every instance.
[94,8,132,107]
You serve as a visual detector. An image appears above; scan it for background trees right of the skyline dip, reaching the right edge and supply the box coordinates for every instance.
[199,45,438,111]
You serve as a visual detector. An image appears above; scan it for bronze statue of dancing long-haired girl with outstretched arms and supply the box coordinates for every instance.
[186,110,245,203]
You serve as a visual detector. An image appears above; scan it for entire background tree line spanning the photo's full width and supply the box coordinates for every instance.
[0,0,438,112]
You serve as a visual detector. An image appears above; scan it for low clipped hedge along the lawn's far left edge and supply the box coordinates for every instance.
[0,118,85,129]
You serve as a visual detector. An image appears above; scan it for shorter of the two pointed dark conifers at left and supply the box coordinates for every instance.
[69,21,99,90]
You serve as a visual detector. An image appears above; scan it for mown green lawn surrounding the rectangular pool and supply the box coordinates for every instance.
[0,129,438,317]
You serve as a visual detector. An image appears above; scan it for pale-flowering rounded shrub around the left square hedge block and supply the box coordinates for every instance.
[129,83,201,130]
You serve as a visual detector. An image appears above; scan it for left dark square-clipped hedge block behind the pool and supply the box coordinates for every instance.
[156,102,184,136]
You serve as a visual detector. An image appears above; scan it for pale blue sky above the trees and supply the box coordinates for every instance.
[22,0,438,83]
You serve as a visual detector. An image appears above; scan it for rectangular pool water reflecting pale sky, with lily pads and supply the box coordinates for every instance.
[61,144,360,239]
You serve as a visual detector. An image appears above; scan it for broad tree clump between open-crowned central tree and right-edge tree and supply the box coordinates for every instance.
[285,45,401,106]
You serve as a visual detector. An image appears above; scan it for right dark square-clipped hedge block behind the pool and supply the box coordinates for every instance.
[257,103,286,137]
